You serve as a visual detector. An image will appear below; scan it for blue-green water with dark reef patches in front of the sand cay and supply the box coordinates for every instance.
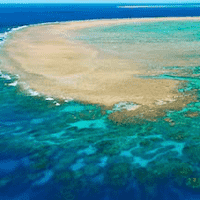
[0,68,200,199]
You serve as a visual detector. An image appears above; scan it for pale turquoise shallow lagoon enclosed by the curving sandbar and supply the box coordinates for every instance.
[76,21,200,69]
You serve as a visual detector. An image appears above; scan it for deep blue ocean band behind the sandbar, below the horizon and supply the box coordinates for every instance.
[0,4,200,29]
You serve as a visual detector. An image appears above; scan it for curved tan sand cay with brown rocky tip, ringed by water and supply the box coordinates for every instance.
[1,17,200,124]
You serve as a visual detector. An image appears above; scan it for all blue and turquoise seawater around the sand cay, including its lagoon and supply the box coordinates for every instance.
[0,4,200,200]
